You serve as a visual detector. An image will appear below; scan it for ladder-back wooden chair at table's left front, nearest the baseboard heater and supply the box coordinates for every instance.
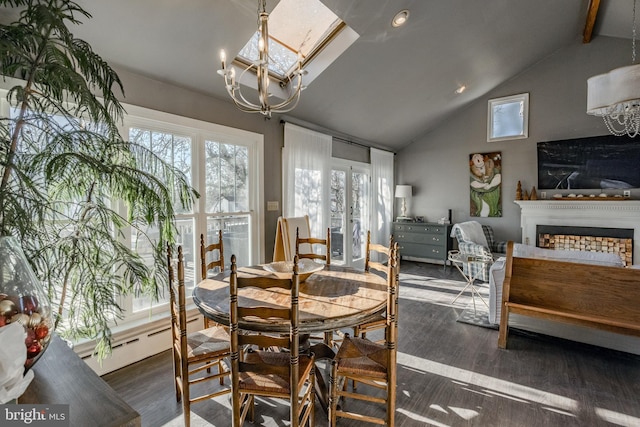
[167,246,231,427]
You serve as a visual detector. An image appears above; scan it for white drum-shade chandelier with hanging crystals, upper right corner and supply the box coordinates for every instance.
[587,0,640,138]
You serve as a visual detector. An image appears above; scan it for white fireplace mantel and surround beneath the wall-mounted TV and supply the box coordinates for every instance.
[516,200,640,265]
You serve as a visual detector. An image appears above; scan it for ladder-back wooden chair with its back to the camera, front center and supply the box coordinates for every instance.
[229,255,315,427]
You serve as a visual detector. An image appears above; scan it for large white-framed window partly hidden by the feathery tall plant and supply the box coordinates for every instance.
[121,107,264,318]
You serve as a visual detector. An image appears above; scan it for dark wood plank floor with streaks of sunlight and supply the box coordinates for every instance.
[104,261,640,427]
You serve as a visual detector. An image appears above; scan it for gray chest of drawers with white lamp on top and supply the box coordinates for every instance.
[393,222,452,265]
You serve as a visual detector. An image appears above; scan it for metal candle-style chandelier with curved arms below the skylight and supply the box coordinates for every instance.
[218,0,306,118]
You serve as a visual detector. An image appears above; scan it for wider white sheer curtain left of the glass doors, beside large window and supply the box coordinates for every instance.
[282,123,332,237]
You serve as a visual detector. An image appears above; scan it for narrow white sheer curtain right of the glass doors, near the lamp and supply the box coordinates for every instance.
[370,148,394,246]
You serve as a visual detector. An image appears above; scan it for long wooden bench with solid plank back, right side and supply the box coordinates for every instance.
[498,242,640,348]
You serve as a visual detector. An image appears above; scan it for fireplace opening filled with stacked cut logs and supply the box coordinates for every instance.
[536,224,633,266]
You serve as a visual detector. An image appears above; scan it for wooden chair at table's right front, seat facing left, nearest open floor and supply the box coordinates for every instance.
[329,243,399,427]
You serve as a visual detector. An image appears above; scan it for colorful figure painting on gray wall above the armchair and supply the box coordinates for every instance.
[469,151,502,217]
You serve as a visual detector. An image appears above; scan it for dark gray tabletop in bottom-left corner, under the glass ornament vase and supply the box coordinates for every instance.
[18,335,141,427]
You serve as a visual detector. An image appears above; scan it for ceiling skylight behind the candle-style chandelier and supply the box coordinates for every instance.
[238,0,344,79]
